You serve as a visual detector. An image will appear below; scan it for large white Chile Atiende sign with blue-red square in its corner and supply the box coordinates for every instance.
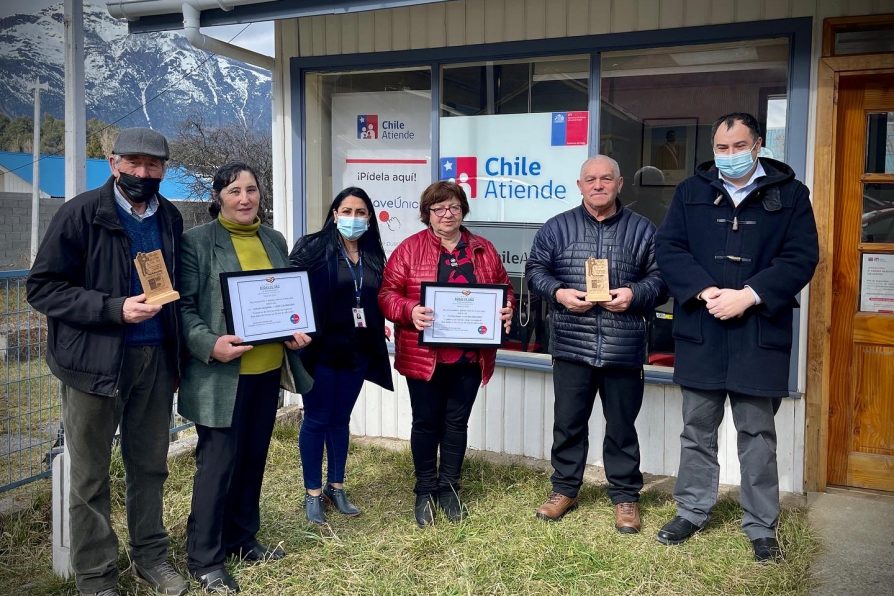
[438,112,589,223]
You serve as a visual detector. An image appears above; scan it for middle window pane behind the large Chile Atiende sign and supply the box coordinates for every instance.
[438,56,590,352]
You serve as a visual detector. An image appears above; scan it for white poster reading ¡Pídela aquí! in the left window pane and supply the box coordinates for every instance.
[332,91,431,255]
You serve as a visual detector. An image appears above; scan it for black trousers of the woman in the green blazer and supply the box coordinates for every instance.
[186,369,280,575]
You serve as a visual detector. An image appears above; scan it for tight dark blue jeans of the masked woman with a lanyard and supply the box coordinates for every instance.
[298,358,367,489]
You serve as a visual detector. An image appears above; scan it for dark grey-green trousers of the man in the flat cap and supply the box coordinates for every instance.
[62,347,174,592]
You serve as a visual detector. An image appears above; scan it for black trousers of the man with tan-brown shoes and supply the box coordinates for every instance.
[552,359,643,504]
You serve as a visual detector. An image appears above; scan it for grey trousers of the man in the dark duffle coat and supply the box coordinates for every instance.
[674,387,781,540]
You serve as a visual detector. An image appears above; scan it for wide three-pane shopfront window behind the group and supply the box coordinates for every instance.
[303,32,804,366]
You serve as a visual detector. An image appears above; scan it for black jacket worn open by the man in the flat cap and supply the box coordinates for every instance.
[27,178,183,396]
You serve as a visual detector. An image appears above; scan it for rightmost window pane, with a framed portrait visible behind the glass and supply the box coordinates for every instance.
[599,39,789,225]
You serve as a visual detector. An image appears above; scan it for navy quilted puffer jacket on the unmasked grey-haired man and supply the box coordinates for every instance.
[525,201,667,367]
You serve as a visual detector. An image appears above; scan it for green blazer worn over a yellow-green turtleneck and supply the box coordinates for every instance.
[177,219,313,427]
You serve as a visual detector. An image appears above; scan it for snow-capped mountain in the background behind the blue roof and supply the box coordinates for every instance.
[0,3,270,133]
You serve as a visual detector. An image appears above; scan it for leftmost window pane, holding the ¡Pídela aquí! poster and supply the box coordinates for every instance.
[305,68,432,254]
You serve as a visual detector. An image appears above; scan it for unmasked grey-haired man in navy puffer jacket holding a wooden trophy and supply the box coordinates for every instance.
[525,155,667,534]
